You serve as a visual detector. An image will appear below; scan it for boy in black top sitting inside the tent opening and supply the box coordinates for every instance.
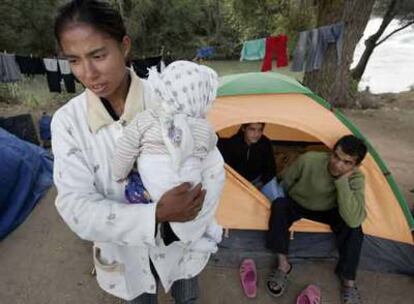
[218,122,284,202]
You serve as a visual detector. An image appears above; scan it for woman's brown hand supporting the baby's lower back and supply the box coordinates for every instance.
[155,183,206,222]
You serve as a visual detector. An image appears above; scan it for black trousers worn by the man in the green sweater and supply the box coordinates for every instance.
[267,197,364,280]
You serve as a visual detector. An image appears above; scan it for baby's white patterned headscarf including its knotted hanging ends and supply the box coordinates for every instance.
[148,61,218,170]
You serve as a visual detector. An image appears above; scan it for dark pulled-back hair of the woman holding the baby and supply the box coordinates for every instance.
[55,0,126,44]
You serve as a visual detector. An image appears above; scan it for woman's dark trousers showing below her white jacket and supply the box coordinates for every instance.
[127,277,199,304]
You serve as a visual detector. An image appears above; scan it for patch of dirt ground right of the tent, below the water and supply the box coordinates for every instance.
[344,92,414,208]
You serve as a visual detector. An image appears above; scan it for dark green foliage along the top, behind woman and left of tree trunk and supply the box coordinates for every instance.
[0,0,315,59]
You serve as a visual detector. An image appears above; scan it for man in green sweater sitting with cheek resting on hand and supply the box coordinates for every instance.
[267,135,367,303]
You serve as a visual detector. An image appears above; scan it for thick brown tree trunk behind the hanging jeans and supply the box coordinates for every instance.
[304,0,375,107]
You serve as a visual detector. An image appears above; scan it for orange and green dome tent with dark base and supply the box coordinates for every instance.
[209,72,414,274]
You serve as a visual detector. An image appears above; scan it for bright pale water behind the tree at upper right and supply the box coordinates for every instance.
[352,18,414,93]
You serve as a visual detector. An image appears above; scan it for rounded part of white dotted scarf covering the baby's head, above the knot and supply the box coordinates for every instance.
[148,60,218,118]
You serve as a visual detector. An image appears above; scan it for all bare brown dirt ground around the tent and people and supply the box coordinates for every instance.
[0,93,414,304]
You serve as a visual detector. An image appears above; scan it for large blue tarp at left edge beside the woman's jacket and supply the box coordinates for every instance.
[0,128,53,240]
